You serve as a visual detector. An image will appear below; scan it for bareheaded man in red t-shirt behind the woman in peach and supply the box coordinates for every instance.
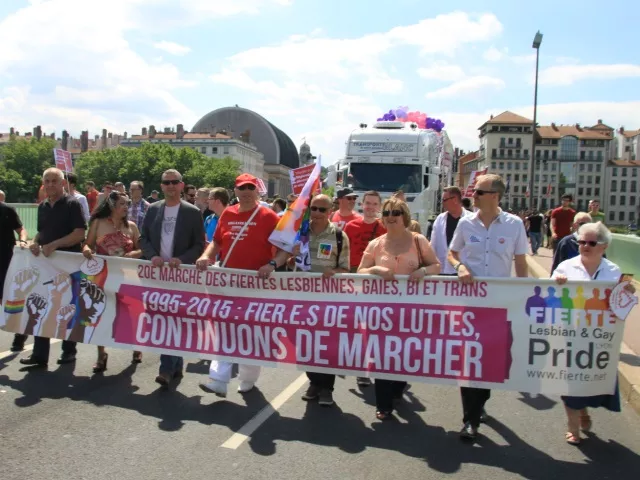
[344,190,387,273]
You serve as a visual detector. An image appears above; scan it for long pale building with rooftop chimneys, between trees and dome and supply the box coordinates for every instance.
[120,124,266,182]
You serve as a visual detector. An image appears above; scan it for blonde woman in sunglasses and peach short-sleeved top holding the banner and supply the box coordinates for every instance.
[358,197,440,420]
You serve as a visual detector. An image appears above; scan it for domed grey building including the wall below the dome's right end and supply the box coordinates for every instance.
[191,105,300,197]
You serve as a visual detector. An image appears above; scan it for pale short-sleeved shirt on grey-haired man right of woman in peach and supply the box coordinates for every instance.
[449,210,529,277]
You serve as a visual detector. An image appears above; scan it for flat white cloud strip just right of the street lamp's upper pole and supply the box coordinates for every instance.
[540,64,640,86]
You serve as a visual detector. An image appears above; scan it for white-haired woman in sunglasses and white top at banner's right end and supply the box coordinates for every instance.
[551,222,635,445]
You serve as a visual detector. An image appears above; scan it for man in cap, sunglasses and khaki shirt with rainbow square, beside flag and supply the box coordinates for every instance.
[302,195,349,407]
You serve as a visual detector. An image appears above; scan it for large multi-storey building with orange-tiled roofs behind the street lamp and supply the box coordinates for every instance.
[478,111,614,216]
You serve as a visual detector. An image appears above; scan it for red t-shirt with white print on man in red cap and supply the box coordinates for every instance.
[213,205,280,270]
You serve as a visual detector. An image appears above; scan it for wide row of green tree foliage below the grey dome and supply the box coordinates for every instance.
[75,143,240,195]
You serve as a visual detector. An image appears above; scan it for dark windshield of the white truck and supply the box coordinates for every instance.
[350,163,422,193]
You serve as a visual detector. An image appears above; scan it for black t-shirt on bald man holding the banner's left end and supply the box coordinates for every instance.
[38,194,87,252]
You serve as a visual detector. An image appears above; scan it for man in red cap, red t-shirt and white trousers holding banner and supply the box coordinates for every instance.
[196,173,289,397]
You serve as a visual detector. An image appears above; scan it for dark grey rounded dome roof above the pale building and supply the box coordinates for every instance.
[191,107,300,168]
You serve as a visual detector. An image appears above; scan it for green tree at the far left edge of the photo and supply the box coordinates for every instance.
[0,136,56,202]
